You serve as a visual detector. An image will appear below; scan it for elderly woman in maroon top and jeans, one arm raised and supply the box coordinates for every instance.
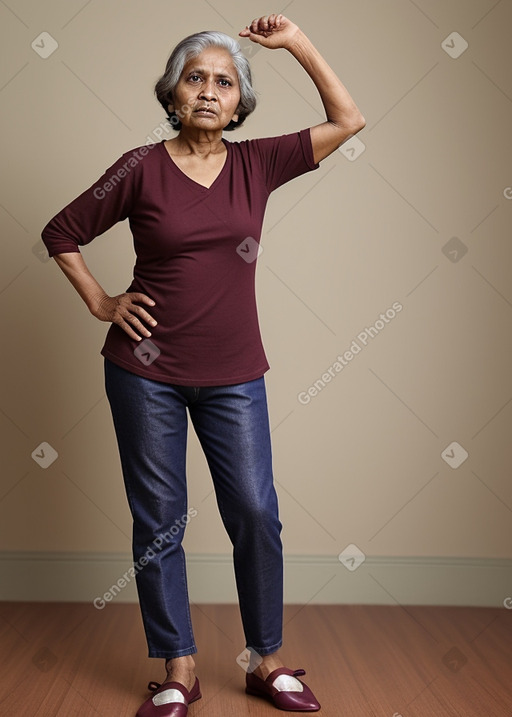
[42,14,365,717]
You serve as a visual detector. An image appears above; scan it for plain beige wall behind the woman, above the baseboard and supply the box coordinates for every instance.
[0,0,512,592]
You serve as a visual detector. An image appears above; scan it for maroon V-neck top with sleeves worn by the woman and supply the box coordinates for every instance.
[42,128,319,386]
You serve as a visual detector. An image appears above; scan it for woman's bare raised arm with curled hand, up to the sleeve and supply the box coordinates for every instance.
[239,14,366,162]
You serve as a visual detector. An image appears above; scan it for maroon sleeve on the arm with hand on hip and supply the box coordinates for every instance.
[41,150,137,256]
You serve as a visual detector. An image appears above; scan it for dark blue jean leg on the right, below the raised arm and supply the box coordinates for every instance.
[189,377,283,655]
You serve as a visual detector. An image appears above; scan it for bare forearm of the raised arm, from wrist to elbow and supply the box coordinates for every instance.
[286,29,365,131]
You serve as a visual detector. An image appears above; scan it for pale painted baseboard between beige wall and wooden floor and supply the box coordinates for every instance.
[0,552,512,607]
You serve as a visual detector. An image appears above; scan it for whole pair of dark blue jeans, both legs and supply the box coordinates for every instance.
[105,359,283,658]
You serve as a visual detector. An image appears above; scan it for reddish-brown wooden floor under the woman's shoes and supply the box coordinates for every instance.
[0,603,512,717]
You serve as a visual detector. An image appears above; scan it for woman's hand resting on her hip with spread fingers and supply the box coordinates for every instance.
[91,292,157,341]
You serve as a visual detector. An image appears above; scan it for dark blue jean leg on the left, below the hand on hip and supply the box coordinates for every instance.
[105,360,197,658]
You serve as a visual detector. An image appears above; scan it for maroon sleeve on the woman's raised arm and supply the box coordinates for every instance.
[251,127,320,193]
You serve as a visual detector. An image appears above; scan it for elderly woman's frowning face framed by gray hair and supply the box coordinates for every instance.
[170,47,240,130]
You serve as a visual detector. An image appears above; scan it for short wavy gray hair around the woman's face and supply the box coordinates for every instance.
[155,30,256,130]
